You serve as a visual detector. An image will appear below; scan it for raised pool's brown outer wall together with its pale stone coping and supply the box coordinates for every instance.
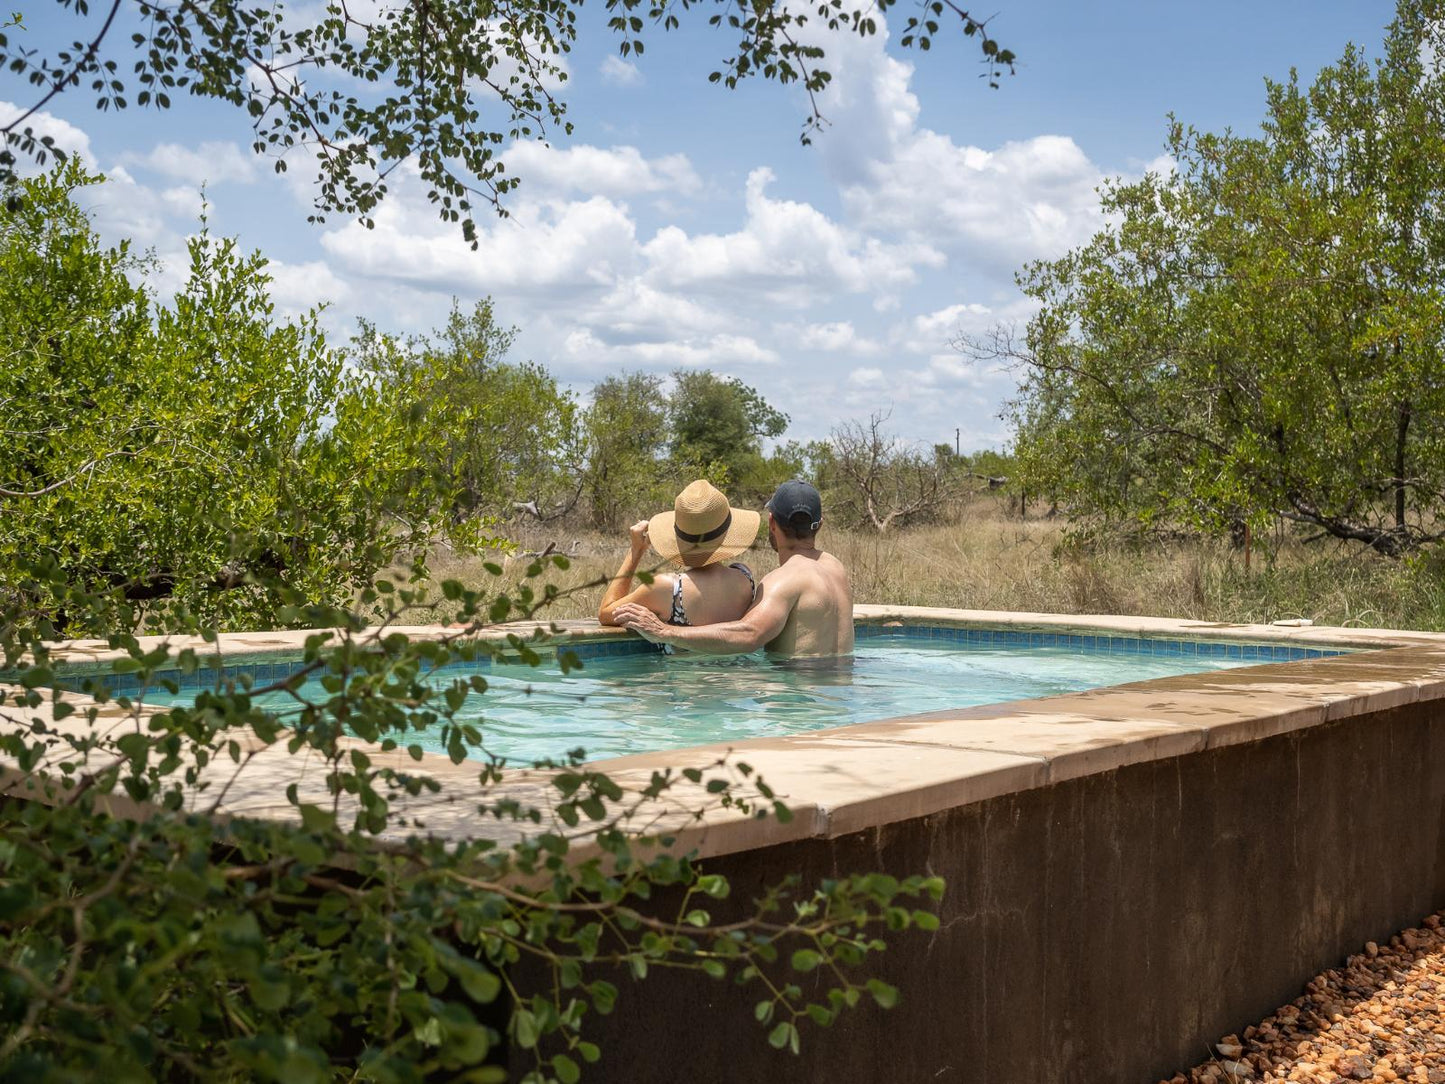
[6,607,1445,1084]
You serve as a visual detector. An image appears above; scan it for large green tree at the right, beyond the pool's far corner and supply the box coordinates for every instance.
[994,0,1445,555]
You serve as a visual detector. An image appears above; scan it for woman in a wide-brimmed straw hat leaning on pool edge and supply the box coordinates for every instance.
[597,480,762,641]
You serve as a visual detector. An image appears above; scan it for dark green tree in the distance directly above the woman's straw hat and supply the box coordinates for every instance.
[668,369,788,496]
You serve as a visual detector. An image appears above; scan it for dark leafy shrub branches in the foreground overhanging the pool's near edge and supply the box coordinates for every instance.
[0,558,942,1084]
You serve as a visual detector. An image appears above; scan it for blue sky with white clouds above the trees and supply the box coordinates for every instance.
[0,0,1393,451]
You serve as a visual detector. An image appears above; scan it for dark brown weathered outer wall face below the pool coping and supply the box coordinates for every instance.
[557,702,1445,1084]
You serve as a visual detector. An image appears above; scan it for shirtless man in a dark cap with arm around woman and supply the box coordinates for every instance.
[613,481,853,658]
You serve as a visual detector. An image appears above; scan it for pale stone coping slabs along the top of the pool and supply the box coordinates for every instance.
[8,606,1445,857]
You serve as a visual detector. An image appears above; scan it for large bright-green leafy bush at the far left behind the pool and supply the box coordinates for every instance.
[0,162,462,635]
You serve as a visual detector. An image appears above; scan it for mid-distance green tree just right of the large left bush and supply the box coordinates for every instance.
[351,298,584,519]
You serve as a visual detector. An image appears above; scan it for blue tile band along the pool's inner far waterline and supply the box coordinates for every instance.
[22,624,1348,697]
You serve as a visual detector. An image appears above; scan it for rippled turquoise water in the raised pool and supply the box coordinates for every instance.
[130,639,1261,763]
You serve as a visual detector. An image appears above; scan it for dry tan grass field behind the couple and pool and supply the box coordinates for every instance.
[410,497,1445,629]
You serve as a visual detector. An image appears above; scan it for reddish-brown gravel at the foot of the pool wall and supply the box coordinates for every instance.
[1160,915,1445,1084]
